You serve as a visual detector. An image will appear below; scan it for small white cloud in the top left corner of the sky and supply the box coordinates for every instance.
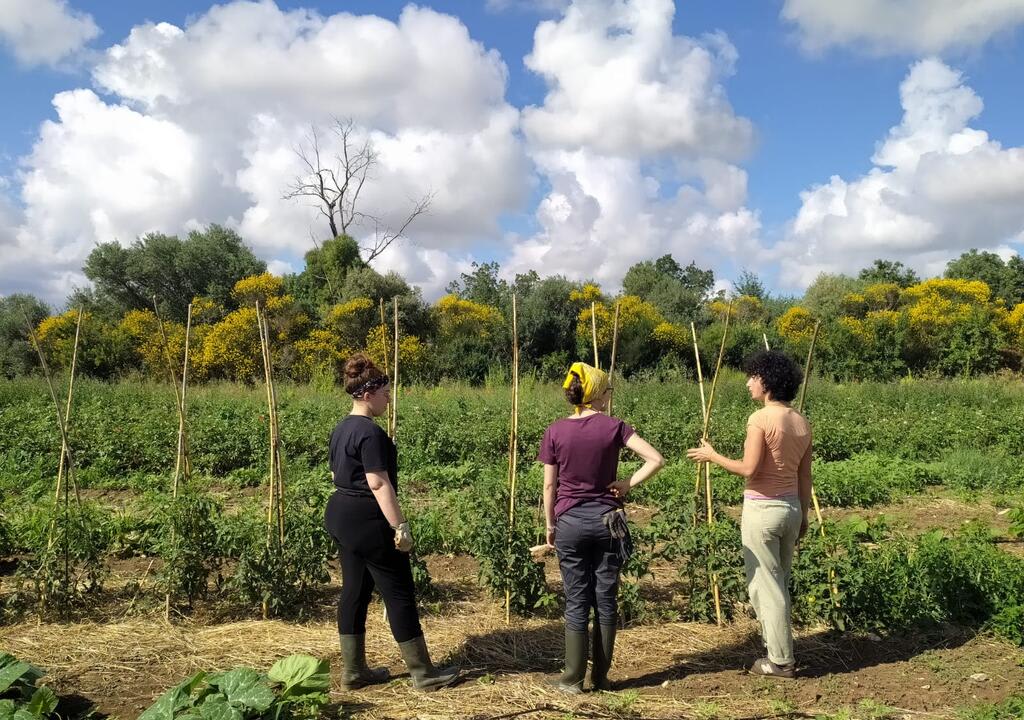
[0,0,99,67]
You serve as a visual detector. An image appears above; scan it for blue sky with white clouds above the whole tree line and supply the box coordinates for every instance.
[0,0,1024,300]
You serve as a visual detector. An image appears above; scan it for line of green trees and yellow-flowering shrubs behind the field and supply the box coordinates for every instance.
[0,225,1024,383]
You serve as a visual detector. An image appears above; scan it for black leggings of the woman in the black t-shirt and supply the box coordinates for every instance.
[324,493,423,642]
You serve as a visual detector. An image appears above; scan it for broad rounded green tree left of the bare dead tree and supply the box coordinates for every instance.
[82,225,266,321]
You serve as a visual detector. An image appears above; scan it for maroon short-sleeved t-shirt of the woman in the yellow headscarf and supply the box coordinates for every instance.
[537,413,633,517]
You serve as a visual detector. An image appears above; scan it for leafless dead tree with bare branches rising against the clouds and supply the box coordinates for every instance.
[284,118,433,263]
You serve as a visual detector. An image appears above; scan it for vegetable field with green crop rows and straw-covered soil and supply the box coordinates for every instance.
[0,374,1024,720]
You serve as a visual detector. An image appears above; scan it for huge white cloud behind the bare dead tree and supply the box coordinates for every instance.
[6,0,529,295]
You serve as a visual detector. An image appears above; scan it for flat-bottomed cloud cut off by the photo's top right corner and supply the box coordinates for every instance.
[782,0,1024,55]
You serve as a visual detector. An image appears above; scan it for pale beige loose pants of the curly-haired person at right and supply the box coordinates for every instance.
[740,498,803,665]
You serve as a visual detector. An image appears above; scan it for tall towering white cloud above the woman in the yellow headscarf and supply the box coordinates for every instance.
[505,0,761,287]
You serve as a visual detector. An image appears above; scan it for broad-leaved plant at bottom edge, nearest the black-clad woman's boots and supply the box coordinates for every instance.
[139,654,331,720]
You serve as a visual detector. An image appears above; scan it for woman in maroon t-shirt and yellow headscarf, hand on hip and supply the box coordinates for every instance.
[538,363,665,693]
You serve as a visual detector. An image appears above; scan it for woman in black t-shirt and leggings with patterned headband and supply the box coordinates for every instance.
[324,353,459,690]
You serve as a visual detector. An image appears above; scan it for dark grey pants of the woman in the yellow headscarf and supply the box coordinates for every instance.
[555,503,622,632]
